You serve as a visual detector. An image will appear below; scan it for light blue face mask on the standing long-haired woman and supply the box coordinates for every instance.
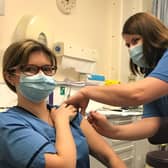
[129,45,149,68]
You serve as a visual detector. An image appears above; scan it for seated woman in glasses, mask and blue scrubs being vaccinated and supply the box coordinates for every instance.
[0,39,126,168]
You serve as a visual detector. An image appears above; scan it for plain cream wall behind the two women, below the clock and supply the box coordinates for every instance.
[0,0,152,80]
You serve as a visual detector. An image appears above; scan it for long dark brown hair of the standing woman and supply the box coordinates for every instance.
[122,12,168,75]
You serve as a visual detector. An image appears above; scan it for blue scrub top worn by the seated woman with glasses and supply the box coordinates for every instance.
[0,106,90,168]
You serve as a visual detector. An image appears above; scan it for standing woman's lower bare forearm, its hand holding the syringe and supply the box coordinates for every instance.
[88,112,160,140]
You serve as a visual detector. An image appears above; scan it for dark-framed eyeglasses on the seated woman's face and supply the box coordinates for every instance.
[8,64,57,76]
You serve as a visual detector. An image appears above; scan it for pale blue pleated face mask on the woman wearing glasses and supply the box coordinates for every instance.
[17,74,56,102]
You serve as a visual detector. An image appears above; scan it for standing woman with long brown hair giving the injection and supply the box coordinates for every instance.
[66,13,168,140]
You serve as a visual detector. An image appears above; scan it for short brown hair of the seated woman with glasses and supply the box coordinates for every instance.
[2,39,57,92]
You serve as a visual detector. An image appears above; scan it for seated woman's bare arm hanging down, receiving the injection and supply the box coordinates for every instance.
[81,119,126,168]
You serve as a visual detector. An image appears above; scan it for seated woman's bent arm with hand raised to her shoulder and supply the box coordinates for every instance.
[45,104,76,168]
